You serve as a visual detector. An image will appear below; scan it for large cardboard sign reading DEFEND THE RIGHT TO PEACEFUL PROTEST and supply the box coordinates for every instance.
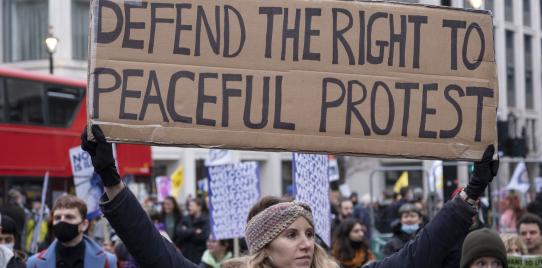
[87,0,498,160]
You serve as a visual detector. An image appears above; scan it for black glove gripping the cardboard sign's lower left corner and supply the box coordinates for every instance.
[81,125,120,187]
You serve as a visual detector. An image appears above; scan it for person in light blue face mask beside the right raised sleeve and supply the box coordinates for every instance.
[383,203,422,256]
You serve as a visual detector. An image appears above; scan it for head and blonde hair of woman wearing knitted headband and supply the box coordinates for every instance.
[223,196,339,268]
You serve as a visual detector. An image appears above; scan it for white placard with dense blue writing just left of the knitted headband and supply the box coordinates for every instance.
[209,162,260,239]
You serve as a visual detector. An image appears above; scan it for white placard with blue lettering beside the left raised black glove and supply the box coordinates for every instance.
[69,146,104,219]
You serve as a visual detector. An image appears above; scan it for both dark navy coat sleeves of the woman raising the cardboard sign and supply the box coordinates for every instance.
[101,188,476,268]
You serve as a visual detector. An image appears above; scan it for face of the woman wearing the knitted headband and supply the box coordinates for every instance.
[265,217,314,268]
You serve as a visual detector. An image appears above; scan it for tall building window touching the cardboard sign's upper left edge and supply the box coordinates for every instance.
[72,0,90,60]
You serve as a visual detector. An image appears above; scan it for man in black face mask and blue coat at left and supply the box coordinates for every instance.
[27,195,117,268]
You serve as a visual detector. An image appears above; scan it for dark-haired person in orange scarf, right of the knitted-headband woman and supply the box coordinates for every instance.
[331,218,375,268]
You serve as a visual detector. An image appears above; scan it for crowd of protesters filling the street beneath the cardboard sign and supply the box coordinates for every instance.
[0,127,542,268]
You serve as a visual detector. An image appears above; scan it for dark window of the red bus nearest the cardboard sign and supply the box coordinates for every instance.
[46,86,83,127]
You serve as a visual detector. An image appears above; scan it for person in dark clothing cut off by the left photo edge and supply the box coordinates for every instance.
[0,215,26,268]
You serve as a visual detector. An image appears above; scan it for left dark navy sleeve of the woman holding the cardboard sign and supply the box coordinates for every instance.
[100,187,198,268]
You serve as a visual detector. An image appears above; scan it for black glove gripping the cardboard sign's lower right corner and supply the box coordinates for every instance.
[465,145,499,200]
